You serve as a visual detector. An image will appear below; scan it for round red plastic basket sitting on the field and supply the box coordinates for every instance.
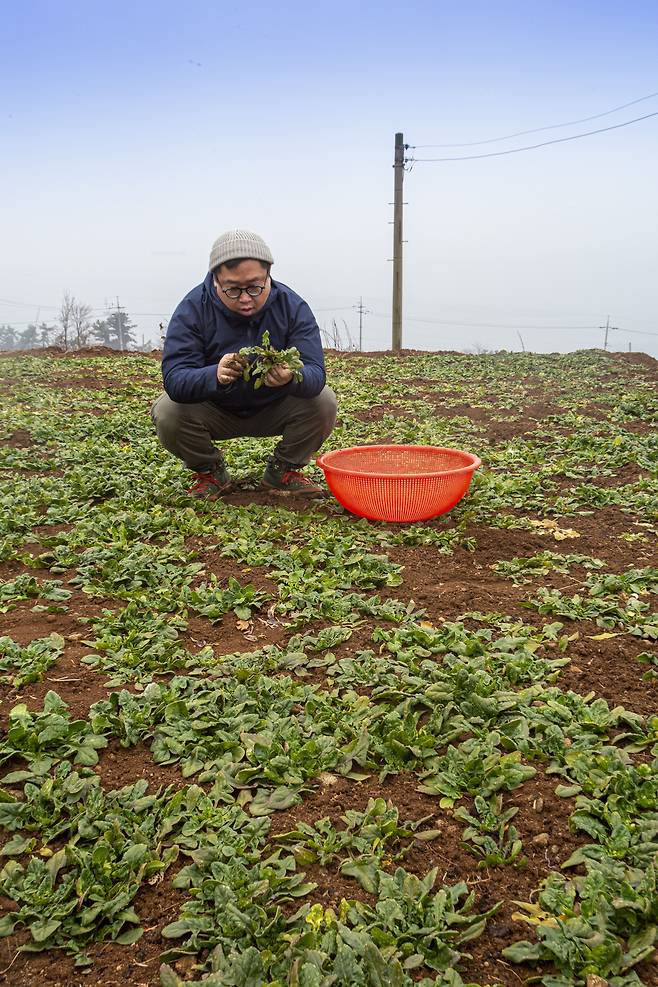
[316,445,481,521]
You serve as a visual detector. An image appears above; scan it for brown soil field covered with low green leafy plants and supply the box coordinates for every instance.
[0,351,658,987]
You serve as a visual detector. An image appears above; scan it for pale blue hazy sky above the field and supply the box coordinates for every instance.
[0,0,658,355]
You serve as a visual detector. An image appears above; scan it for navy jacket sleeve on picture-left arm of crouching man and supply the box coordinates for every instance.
[162,298,221,404]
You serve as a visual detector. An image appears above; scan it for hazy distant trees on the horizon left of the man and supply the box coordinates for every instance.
[0,291,152,351]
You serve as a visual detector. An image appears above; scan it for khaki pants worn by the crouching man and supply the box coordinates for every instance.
[151,387,337,473]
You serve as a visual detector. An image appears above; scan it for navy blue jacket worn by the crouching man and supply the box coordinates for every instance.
[162,273,326,417]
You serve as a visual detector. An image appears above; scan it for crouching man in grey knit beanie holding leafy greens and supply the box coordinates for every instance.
[151,230,336,497]
